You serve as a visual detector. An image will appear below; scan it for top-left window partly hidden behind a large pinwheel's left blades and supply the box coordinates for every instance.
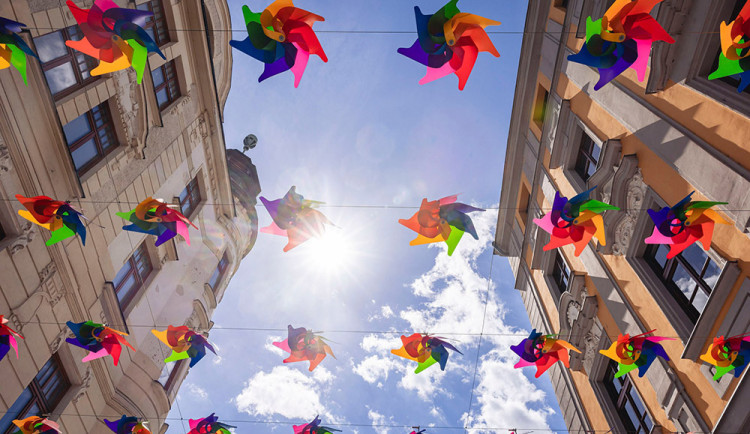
[34,26,98,99]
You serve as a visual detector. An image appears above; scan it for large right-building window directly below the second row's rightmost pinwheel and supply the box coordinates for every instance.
[643,244,721,324]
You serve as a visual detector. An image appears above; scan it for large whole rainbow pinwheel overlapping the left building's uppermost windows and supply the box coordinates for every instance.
[65,0,166,84]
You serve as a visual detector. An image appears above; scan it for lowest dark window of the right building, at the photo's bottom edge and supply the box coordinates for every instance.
[602,361,654,434]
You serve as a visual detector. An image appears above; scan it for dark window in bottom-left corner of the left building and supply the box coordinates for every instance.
[0,355,70,434]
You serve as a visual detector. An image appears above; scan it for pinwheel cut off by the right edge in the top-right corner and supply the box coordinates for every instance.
[708,1,750,92]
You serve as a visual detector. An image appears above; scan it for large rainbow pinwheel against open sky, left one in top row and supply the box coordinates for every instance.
[229,0,328,87]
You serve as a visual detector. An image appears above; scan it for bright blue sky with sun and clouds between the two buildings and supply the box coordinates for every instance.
[168,0,564,433]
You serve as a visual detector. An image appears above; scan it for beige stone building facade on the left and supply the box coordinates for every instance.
[0,0,260,433]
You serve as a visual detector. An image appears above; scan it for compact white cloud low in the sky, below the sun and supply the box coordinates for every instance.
[234,366,332,419]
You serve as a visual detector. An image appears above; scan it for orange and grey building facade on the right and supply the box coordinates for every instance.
[494,0,750,433]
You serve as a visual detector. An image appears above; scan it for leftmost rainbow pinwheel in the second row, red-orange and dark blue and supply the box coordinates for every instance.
[16,194,86,246]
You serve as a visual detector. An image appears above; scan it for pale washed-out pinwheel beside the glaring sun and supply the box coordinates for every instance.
[260,186,333,252]
